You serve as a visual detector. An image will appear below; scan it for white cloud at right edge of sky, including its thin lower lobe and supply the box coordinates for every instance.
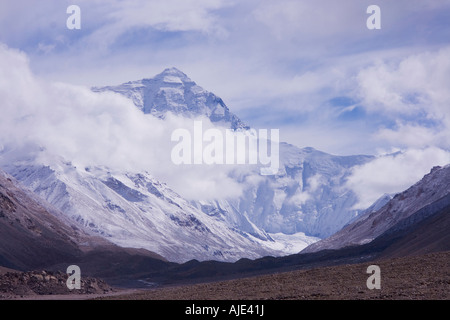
[357,46,450,149]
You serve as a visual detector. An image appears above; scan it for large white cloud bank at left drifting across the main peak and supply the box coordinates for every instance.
[0,46,242,200]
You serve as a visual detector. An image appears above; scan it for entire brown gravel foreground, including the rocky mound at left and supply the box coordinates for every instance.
[0,251,450,300]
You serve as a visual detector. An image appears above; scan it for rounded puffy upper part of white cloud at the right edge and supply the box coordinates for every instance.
[358,47,450,118]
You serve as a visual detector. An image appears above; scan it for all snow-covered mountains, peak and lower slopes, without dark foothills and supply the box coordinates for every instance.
[0,68,382,262]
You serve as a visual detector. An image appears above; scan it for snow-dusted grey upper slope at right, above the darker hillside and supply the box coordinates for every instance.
[302,165,450,253]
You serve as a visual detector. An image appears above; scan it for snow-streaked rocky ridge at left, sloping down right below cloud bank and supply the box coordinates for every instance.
[1,160,282,262]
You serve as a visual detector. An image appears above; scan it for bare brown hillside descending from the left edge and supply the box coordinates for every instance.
[0,171,89,270]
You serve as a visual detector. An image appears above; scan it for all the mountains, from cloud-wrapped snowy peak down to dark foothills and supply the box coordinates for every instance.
[0,68,450,282]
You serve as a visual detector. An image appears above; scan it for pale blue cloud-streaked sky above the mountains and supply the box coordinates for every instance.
[0,0,450,205]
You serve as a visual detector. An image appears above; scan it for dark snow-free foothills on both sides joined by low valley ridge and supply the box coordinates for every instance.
[0,165,450,286]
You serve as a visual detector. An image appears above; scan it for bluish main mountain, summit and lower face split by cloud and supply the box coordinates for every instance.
[93,68,373,239]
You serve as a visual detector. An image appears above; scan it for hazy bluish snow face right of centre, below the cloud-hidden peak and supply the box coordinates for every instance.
[195,143,372,238]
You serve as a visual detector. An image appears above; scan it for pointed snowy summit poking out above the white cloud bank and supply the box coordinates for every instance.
[92,68,249,130]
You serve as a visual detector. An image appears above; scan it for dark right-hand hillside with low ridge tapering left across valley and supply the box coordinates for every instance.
[135,165,450,283]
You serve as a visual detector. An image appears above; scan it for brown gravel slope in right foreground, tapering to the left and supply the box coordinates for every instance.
[96,251,450,300]
